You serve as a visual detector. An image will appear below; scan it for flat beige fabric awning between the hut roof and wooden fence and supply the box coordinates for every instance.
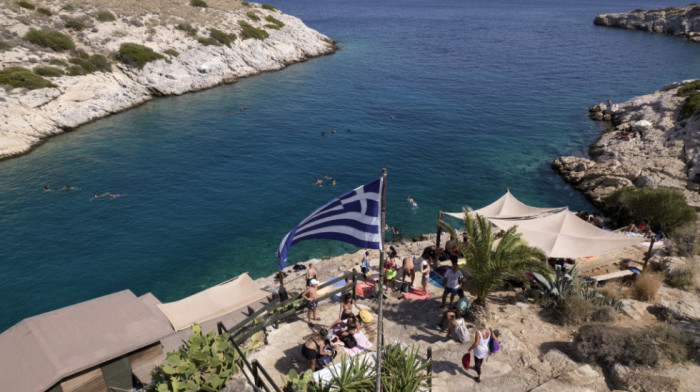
[158,273,269,331]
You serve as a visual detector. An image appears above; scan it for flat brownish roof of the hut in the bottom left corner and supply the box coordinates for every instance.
[0,290,173,392]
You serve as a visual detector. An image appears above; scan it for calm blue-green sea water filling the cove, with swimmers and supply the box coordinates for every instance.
[0,0,700,330]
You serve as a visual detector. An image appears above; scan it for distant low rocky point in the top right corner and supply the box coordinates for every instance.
[593,4,700,42]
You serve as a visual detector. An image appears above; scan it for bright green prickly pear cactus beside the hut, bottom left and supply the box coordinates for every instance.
[147,324,240,392]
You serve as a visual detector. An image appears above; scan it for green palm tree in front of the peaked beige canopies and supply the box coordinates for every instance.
[440,210,551,307]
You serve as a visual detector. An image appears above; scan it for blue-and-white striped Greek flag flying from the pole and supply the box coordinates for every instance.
[276,178,382,269]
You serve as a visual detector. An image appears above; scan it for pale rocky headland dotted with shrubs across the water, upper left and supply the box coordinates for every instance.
[0,0,337,159]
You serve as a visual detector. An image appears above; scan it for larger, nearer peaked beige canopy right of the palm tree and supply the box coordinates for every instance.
[489,210,639,258]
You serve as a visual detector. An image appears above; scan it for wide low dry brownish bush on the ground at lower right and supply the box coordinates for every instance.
[574,324,697,366]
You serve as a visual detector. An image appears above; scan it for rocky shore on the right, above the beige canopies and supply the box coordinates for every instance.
[552,81,700,207]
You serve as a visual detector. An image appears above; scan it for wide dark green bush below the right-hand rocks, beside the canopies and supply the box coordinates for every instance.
[601,187,697,234]
